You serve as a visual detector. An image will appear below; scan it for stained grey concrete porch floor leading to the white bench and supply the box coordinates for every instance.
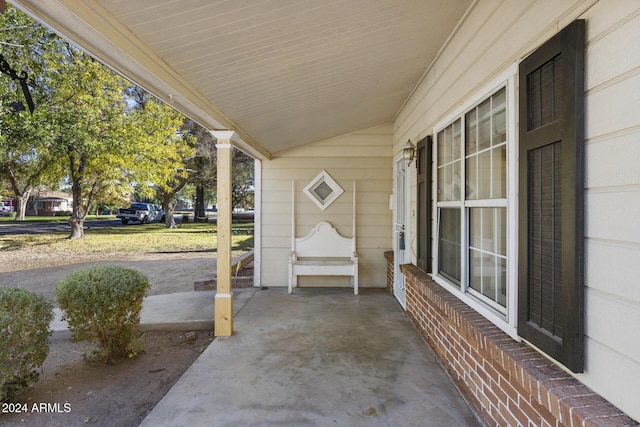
[141,288,480,427]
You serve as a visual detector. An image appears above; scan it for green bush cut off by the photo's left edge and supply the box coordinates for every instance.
[0,287,53,402]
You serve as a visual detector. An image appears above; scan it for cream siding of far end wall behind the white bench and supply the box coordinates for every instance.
[261,124,393,287]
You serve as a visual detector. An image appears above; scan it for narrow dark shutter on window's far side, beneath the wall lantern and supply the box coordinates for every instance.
[416,136,432,273]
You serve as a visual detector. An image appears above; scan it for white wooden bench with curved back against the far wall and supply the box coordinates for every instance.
[289,221,358,295]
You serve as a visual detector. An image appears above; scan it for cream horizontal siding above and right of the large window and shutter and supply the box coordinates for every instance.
[393,0,640,420]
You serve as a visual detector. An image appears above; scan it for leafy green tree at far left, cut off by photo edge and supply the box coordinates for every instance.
[0,6,61,220]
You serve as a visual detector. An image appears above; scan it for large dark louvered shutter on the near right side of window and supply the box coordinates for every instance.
[518,20,584,372]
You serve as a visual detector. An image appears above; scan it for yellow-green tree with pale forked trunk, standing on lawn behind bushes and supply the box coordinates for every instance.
[46,42,143,239]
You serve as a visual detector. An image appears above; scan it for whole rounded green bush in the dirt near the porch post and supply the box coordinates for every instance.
[56,265,149,363]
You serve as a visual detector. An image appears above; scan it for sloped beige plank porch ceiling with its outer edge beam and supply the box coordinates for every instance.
[11,0,471,158]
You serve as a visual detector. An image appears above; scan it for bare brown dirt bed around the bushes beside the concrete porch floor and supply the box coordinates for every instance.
[0,331,212,427]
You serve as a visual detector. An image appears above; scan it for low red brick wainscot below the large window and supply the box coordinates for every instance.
[387,257,638,427]
